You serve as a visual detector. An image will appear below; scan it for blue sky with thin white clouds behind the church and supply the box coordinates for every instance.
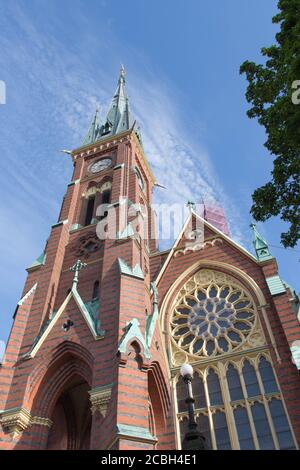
[0,0,300,352]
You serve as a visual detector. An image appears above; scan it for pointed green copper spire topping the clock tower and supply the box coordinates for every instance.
[82,65,137,145]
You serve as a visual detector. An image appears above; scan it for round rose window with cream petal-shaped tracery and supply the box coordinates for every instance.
[171,270,255,356]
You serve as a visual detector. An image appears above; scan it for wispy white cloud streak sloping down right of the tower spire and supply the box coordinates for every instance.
[127,77,244,244]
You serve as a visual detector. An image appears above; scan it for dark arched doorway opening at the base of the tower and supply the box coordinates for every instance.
[47,376,92,450]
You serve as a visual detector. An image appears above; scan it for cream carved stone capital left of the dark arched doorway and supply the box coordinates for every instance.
[0,408,52,438]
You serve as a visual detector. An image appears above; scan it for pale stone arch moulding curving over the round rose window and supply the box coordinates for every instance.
[160,260,281,368]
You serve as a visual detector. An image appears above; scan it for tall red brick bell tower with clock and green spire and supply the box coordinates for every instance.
[0,67,175,449]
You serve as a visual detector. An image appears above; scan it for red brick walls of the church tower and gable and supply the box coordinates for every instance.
[0,96,300,450]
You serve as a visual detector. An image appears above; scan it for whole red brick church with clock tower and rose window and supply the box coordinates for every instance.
[0,68,300,450]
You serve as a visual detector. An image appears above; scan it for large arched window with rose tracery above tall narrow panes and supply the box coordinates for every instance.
[169,269,297,450]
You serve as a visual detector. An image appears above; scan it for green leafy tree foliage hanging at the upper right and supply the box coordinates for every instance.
[240,0,300,247]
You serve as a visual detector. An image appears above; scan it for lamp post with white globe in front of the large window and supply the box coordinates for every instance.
[180,364,208,450]
